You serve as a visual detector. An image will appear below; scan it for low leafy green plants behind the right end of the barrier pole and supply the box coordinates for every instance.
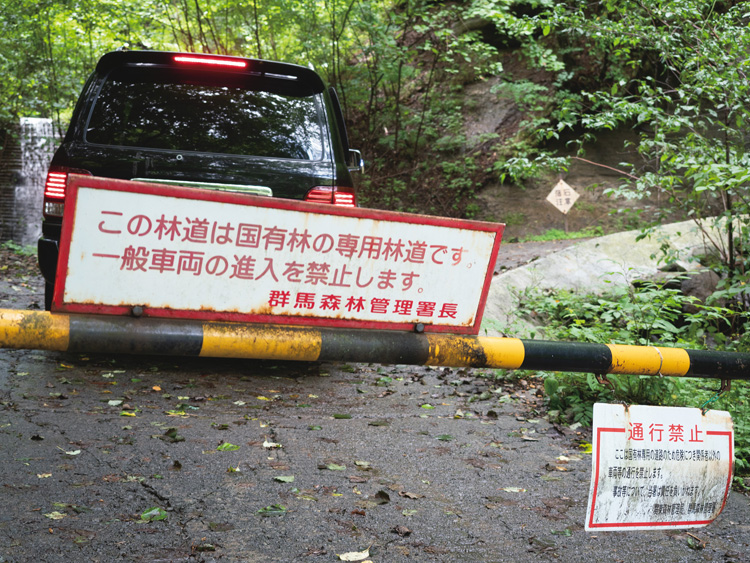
[519,283,750,474]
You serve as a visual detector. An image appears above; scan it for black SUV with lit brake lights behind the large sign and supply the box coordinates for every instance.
[38,51,362,310]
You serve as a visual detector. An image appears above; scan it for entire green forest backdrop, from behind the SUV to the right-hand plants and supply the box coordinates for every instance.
[0,0,750,480]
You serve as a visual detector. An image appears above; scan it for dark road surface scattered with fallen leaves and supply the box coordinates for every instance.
[0,248,750,563]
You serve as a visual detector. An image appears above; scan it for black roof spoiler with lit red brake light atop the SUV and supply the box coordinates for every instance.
[96,51,325,92]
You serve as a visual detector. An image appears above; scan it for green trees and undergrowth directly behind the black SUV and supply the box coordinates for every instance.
[0,0,536,215]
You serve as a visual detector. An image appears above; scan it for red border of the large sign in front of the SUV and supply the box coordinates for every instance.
[52,174,505,334]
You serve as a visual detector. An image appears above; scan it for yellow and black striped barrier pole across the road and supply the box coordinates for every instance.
[0,309,750,380]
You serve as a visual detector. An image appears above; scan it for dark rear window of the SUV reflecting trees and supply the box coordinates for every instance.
[86,67,324,160]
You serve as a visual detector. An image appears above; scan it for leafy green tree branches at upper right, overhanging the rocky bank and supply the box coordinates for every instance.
[524,0,750,311]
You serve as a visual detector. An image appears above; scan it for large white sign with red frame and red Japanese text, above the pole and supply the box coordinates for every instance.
[54,177,502,331]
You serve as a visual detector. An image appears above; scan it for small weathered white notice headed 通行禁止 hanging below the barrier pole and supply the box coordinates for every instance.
[586,404,734,531]
